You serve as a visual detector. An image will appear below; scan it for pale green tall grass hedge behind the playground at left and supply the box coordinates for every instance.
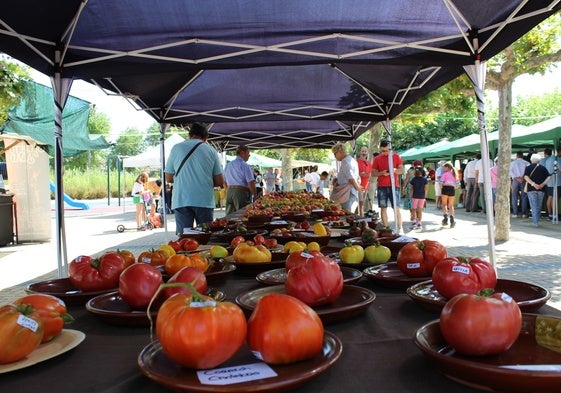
[55,169,138,199]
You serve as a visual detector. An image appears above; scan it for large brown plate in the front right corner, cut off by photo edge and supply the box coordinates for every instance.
[415,314,561,393]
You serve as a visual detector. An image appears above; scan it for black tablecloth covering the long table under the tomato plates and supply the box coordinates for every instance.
[0,268,560,393]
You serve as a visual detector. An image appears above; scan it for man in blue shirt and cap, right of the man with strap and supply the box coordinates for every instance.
[224,145,255,214]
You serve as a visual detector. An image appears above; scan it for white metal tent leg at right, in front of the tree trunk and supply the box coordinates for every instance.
[464,60,496,266]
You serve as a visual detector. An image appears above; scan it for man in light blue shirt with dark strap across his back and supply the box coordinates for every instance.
[164,123,224,235]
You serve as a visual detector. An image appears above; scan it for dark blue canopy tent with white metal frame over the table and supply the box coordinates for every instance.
[0,0,561,273]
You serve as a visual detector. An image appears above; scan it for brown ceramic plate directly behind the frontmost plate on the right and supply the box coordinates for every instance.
[407,278,551,313]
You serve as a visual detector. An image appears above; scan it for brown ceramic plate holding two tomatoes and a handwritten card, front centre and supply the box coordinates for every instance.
[138,331,343,393]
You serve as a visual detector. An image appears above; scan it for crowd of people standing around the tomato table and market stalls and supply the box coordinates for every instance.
[150,124,561,234]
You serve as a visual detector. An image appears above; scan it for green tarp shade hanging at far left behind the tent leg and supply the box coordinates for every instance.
[0,81,110,156]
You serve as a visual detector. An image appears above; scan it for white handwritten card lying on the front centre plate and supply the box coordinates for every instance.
[197,363,277,385]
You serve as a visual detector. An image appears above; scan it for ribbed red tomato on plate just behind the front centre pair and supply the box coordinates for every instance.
[284,255,343,307]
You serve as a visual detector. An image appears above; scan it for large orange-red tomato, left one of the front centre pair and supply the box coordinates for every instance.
[156,293,247,369]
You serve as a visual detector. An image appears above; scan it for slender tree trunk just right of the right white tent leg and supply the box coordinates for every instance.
[495,79,512,241]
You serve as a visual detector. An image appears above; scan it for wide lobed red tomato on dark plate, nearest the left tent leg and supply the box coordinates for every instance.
[68,252,125,291]
